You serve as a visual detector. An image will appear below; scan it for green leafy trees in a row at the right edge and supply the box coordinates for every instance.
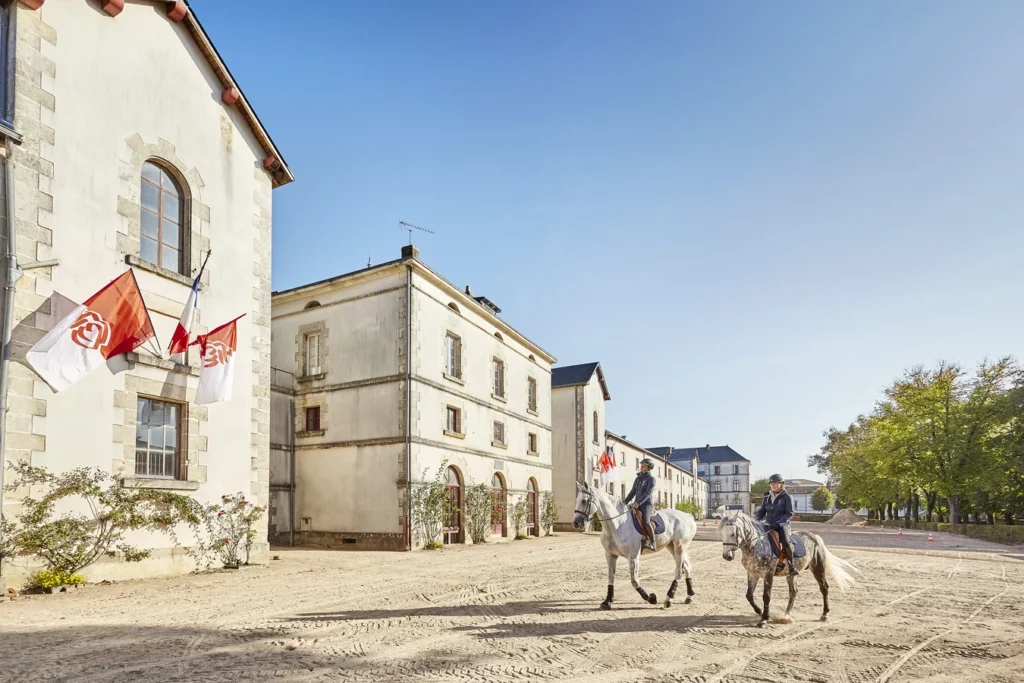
[808,356,1024,524]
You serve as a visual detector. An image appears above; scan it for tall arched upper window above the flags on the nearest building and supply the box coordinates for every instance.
[139,161,188,274]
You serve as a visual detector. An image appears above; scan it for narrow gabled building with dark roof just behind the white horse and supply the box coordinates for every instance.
[550,362,611,530]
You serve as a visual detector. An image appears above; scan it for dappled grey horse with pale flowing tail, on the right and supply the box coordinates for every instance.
[718,512,860,628]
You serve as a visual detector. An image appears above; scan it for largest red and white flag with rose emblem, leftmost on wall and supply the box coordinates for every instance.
[26,269,156,391]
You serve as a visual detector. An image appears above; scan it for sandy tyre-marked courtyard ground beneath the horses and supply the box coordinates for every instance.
[0,524,1024,683]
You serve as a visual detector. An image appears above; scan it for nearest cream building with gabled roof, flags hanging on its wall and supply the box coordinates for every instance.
[0,0,293,580]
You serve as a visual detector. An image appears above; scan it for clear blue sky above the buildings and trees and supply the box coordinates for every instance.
[193,0,1024,476]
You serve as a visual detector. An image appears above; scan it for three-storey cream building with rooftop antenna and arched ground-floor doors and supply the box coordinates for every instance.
[270,247,554,550]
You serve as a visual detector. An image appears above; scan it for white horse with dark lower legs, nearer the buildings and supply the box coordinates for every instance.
[572,482,697,609]
